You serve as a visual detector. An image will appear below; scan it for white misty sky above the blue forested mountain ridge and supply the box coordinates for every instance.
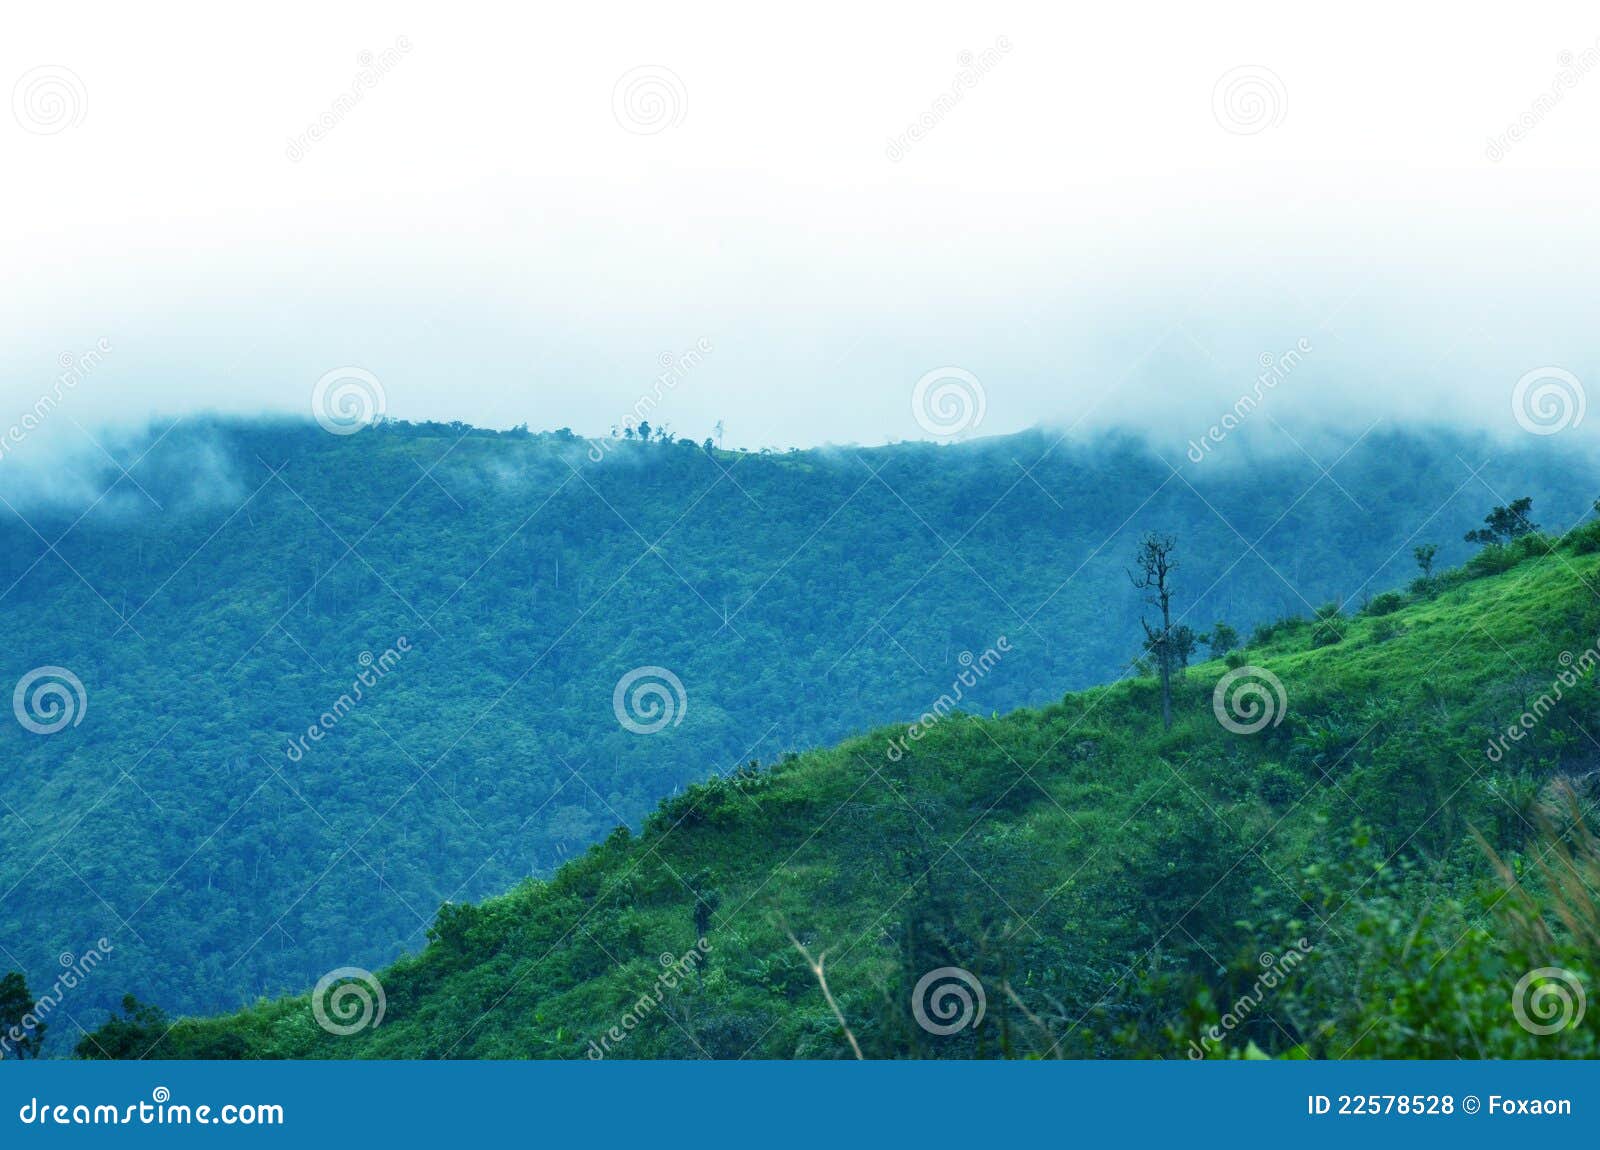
[9,3,1600,464]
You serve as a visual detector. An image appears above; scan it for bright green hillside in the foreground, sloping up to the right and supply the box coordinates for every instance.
[78,526,1600,1059]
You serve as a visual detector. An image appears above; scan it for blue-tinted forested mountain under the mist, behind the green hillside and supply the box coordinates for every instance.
[0,421,1592,1023]
